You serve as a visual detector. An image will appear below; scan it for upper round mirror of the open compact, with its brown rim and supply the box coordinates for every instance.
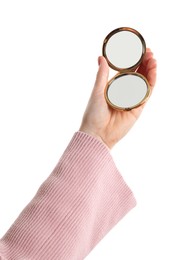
[103,27,146,71]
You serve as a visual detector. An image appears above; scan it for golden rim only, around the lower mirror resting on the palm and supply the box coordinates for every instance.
[104,71,151,111]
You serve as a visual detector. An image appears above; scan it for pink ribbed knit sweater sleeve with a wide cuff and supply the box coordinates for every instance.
[0,131,136,260]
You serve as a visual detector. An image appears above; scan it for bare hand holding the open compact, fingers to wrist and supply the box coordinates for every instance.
[79,49,156,149]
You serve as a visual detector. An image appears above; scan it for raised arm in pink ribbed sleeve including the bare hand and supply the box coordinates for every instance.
[0,49,156,260]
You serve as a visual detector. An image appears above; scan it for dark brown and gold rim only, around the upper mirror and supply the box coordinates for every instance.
[102,27,146,71]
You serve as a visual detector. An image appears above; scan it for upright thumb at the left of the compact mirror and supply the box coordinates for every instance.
[93,56,109,93]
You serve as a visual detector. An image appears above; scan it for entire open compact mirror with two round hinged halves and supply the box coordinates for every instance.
[103,27,150,111]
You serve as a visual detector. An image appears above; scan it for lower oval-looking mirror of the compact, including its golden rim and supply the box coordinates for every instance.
[105,72,150,110]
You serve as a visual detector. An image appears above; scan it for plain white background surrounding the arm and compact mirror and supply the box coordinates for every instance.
[0,0,192,260]
